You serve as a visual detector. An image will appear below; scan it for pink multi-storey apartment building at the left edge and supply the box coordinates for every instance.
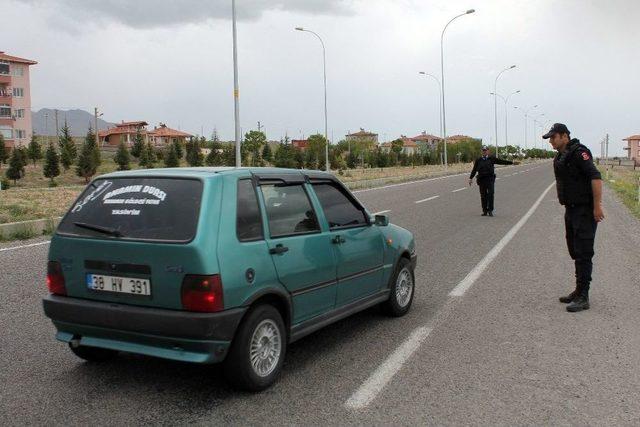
[0,51,37,147]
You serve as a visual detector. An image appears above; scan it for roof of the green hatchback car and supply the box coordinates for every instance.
[96,166,336,180]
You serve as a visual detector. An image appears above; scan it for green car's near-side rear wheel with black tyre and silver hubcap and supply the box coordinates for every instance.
[224,305,287,392]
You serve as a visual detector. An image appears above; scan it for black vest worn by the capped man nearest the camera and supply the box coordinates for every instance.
[553,142,593,206]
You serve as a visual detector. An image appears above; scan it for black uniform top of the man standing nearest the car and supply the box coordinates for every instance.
[553,138,602,206]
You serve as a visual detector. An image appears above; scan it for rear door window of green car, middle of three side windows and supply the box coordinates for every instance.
[260,184,320,237]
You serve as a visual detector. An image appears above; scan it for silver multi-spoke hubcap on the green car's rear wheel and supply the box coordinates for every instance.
[249,319,282,377]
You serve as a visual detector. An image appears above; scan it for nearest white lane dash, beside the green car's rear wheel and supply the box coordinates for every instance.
[344,326,431,409]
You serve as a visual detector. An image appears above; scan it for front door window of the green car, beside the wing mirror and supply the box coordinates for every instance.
[313,183,368,228]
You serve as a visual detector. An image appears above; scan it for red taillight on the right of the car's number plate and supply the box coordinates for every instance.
[182,274,224,312]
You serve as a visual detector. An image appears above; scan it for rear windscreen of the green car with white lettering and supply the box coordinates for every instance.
[57,177,202,242]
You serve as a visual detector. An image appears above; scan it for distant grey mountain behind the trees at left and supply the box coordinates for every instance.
[31,108,115,136]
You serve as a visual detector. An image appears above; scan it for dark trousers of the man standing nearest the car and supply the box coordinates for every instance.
[564,205,598,295]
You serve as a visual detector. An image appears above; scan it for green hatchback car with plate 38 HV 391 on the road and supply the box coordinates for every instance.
[43,168,416,391]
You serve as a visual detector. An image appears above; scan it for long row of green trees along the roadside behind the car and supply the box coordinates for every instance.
[0,123,554,189]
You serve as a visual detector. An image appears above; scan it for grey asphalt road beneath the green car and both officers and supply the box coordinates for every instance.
[0,162,640,425]
